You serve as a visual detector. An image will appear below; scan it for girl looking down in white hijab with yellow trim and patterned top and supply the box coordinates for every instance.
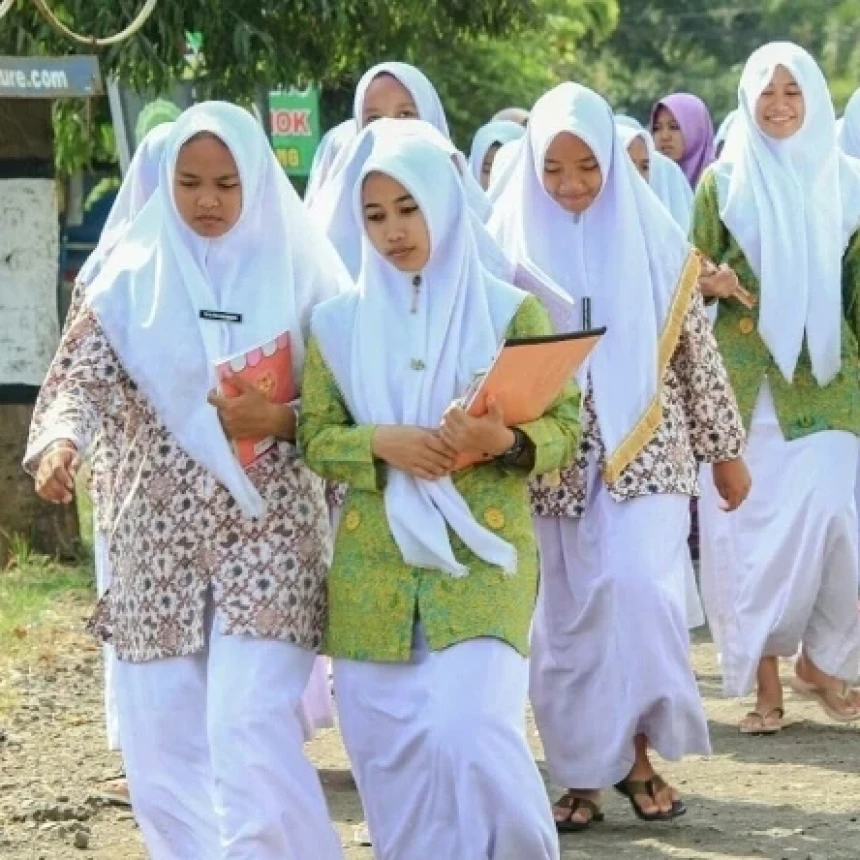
[490,83,747,830]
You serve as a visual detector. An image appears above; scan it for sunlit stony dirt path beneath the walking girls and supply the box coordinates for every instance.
[0,603,860,860]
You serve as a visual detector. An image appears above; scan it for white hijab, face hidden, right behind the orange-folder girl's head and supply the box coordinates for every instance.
[310,119,513,280]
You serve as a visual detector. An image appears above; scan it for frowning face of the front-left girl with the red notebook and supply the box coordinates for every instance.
[173,134,242,239]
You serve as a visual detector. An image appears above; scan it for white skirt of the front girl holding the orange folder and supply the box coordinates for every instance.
[334,627,559,860]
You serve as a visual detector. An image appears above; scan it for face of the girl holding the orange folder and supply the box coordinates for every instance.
[361,173,430,272]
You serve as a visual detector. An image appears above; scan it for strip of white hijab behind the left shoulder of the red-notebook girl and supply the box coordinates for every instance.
[78,122,173,284]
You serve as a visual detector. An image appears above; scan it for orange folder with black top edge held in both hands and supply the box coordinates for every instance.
[454,328,606,470]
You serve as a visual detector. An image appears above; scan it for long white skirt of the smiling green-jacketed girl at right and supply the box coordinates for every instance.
[700,383,860,696]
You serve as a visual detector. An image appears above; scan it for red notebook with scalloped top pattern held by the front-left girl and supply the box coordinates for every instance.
[215,332,296,469]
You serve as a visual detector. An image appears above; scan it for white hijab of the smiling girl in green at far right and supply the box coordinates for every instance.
[714,42,860,385]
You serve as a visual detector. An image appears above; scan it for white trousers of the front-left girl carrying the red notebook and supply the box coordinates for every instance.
[116,621,343,860]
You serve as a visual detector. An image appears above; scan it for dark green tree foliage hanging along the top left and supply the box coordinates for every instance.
[0,0,536,98]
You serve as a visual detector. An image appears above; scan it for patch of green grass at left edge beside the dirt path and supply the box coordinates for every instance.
[0,493,93,716]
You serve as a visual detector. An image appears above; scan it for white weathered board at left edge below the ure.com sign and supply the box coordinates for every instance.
[0,179,60,385]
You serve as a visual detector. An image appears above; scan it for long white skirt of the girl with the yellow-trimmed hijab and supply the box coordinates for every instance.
[531,469,710,789]
